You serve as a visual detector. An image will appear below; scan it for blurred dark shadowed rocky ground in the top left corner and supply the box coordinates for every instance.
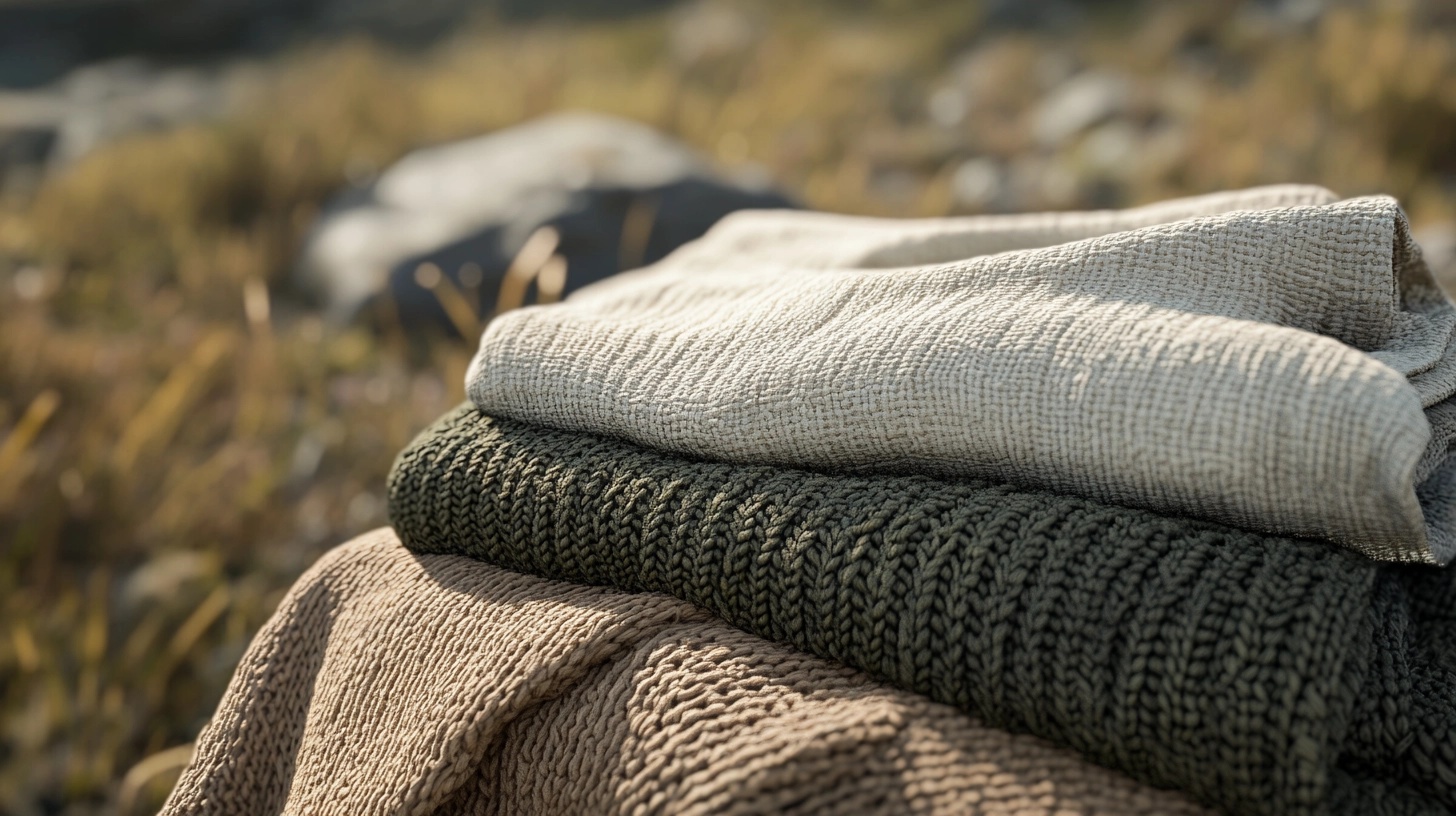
[0,0,667,194]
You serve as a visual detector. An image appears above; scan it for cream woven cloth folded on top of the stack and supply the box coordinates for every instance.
[467,187,1456,562]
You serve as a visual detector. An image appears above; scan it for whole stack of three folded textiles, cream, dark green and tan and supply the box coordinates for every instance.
[172,187,1456,813]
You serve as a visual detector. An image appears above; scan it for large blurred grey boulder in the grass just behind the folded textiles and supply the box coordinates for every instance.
[297,114,794,334]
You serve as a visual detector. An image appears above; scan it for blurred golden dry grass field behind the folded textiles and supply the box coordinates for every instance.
[8,0,1456,815]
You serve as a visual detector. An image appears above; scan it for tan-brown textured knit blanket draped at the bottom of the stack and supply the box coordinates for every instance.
[163,530,1204,816]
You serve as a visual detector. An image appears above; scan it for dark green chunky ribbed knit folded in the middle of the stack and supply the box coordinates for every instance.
[389,405,1456,813]
